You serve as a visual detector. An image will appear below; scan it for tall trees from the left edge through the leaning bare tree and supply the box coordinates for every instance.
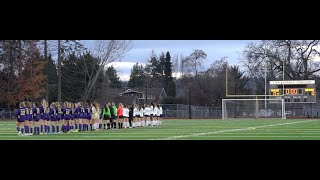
[0,40,131,108]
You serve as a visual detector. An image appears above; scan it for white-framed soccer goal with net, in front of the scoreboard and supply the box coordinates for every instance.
[222,99,286,119]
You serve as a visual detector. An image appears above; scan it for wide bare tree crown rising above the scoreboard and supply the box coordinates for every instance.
[242,40,320,79]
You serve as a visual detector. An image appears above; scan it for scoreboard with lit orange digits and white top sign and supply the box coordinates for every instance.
[269,80,316,103]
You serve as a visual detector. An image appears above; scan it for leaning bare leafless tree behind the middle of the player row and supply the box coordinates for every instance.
[84,40,132,99]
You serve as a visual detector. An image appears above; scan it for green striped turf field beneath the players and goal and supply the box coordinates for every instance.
[0,119,320,140]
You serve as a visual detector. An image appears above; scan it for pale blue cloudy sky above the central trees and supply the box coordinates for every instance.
[83,40,252,80]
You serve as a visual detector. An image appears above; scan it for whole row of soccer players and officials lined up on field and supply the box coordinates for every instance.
[16,100,162,135]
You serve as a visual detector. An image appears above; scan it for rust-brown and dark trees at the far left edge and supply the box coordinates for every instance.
[0,40,46,108]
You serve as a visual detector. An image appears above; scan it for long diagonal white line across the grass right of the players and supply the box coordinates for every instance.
[151,120,316,140]
